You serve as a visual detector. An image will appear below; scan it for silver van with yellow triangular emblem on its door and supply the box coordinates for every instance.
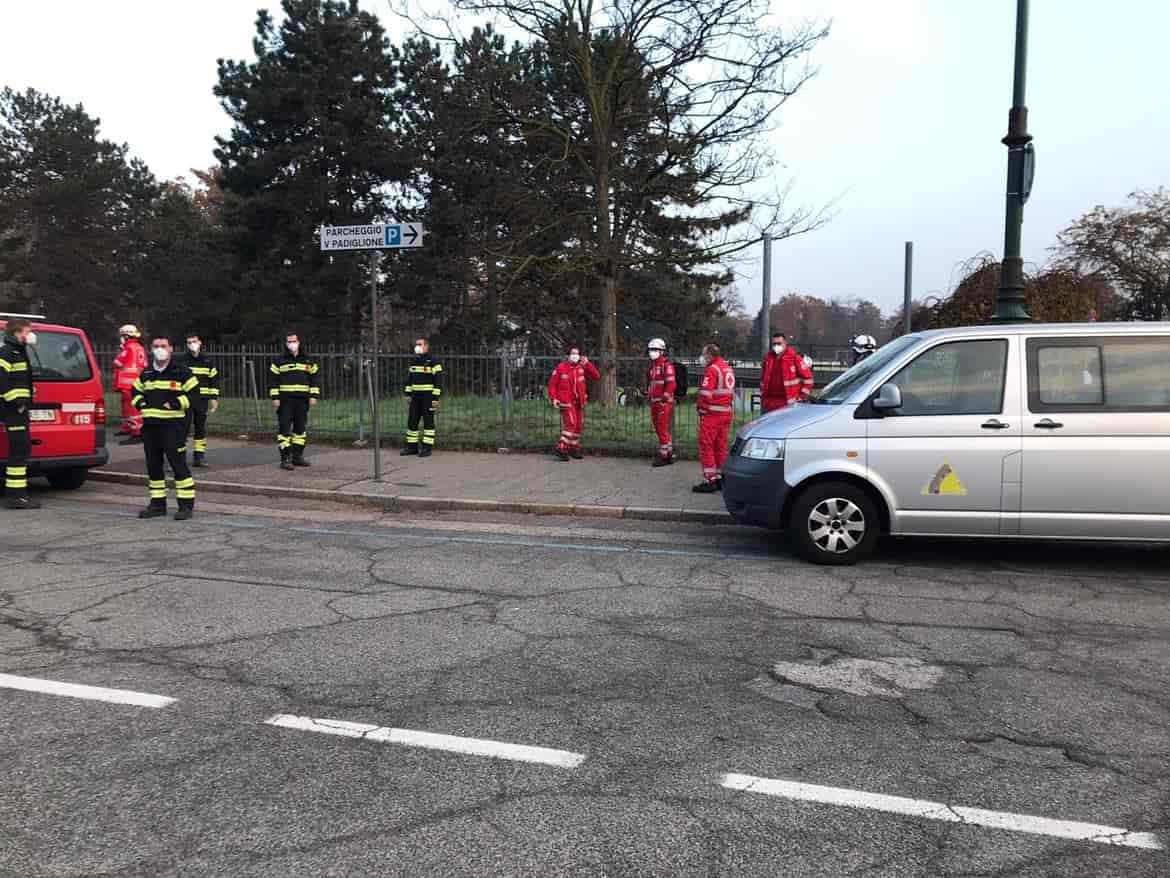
[723,323,1170,564]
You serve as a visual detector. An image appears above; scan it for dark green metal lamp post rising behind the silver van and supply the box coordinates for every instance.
[992,0,1034,323]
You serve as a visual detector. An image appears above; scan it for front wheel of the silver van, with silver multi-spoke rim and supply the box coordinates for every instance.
[787,481,881,565]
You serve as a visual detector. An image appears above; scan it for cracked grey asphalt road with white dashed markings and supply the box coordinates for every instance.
[0,486,1170,878]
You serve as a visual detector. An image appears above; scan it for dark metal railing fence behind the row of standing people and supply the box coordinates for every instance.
[96,347,846,457]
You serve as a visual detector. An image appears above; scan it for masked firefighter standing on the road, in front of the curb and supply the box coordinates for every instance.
[130,336,199,521]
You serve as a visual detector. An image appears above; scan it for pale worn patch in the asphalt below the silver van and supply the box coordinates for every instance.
[772,656,944,698]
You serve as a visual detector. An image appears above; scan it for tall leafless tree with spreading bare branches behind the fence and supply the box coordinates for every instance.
[407,0,828,399]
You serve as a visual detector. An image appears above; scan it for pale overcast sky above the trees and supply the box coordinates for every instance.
[0,0,1170,310]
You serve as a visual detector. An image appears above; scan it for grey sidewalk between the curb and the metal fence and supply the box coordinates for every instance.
[90,437,730,523]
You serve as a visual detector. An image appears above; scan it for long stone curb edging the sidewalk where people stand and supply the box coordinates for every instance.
[89,469,735,524]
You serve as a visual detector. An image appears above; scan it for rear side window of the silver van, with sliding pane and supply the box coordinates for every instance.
[1027,336,1170,412]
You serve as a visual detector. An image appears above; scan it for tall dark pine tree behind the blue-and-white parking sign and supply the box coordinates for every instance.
[215,0,411,341]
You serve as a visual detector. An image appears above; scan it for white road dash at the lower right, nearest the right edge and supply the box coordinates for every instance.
[721,774,1164,851]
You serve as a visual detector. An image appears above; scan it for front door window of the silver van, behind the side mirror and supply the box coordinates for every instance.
[890,338,1007,417]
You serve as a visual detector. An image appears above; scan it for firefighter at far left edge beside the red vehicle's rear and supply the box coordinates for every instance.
[0,317,40,509]
